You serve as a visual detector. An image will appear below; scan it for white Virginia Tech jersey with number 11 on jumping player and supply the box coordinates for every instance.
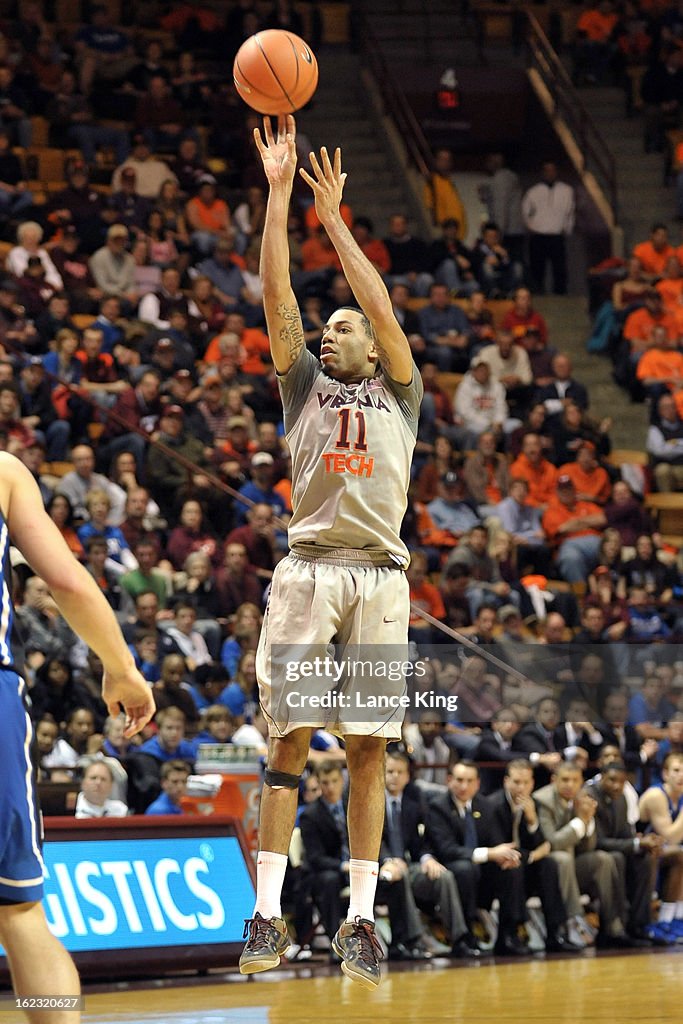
[279,349,423,565]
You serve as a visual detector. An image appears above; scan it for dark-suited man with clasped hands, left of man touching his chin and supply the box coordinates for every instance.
[428,761,529,956]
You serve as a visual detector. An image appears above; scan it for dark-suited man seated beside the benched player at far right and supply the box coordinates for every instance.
[591,762,661,941]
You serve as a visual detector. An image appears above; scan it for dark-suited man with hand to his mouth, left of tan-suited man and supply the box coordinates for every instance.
[487,760,583,952]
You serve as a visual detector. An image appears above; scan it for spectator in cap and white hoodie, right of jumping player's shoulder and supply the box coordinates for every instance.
[453,355,511,449]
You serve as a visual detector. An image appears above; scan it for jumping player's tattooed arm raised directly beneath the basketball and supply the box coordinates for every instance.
[254,115,304,374]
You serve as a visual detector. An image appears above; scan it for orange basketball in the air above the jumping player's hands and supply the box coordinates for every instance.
[232,29,317,114]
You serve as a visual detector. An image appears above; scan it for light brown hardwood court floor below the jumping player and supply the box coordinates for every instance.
[44,947,683,1024]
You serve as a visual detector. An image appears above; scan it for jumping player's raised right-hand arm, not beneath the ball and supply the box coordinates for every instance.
[299,146,413,384]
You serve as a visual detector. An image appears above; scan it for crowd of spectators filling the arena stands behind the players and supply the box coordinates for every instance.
[0,2,683,958]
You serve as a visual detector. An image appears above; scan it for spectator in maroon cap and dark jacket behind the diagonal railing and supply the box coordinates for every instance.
[146,406,209,518]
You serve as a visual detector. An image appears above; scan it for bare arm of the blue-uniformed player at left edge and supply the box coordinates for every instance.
[0,452,155,736]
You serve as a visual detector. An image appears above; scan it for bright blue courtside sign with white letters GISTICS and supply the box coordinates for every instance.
[0,817,254,968]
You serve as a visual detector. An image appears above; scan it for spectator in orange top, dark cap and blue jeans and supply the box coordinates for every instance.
[542,473,607,583]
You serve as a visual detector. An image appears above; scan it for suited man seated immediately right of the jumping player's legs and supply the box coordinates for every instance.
[380,751,480,958]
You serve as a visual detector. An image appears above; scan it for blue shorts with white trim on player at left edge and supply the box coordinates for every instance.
[0,669,44,903]
